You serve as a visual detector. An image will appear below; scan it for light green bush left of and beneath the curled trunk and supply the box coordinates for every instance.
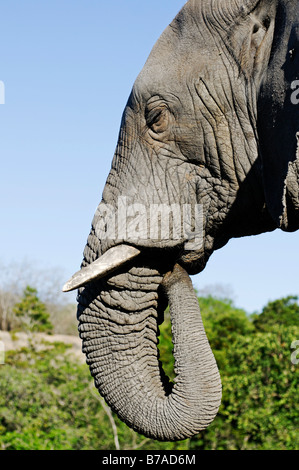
[0,343,188,450]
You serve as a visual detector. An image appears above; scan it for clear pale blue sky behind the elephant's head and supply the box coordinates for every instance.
[0,0,299,311]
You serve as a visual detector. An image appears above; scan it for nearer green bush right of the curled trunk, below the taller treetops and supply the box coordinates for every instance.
[192,327,299,450]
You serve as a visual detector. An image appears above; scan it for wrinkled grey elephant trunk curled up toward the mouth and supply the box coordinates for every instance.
[78,265,221,441]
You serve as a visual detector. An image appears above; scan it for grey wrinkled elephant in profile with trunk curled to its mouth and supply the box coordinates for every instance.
[63,0,299,441]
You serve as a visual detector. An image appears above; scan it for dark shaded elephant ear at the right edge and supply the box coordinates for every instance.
[258,0,299,231]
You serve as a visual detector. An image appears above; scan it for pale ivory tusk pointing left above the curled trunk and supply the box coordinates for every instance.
[62,245,140,292]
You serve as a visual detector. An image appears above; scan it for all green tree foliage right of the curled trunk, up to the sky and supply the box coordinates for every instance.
[191,297,299,450]
